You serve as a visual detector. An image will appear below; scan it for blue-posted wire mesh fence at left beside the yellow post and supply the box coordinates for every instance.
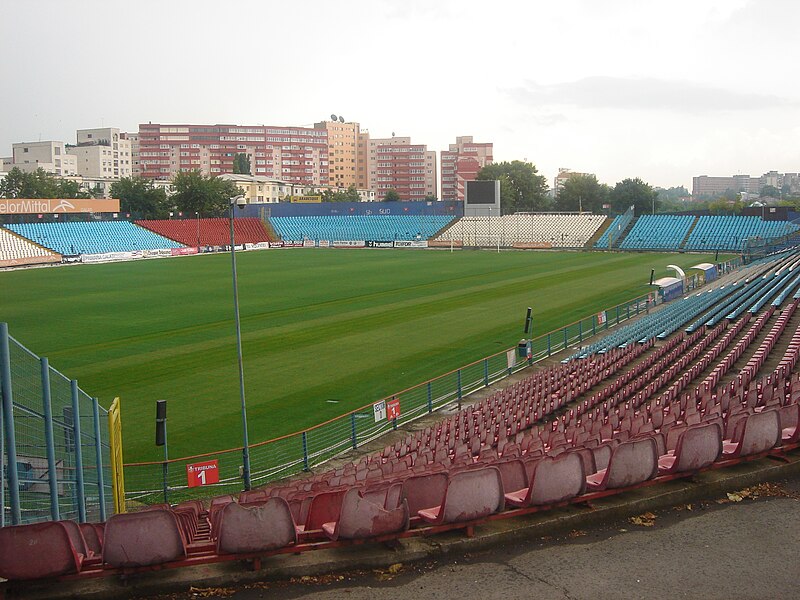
[0,323,113,526]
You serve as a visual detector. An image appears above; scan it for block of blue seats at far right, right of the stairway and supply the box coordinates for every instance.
[685,216,798,251]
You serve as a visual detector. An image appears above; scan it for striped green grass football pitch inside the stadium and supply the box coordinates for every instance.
[0,250,724,462]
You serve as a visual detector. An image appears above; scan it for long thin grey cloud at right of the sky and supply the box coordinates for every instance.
[508,77,800,113]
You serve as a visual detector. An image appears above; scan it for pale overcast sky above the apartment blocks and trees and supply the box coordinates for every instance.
[0,0,800,191]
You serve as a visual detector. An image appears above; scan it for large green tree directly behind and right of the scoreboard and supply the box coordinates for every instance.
[477,160,550,215]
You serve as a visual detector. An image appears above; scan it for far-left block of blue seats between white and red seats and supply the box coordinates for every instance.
[6,221,181,256]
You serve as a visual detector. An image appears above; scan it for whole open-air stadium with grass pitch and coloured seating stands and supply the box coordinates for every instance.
[0,197,800,590]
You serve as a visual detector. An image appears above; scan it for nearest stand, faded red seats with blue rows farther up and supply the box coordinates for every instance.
[0,250,800,592]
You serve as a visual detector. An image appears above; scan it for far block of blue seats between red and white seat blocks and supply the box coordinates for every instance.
[270,215,453,241]
